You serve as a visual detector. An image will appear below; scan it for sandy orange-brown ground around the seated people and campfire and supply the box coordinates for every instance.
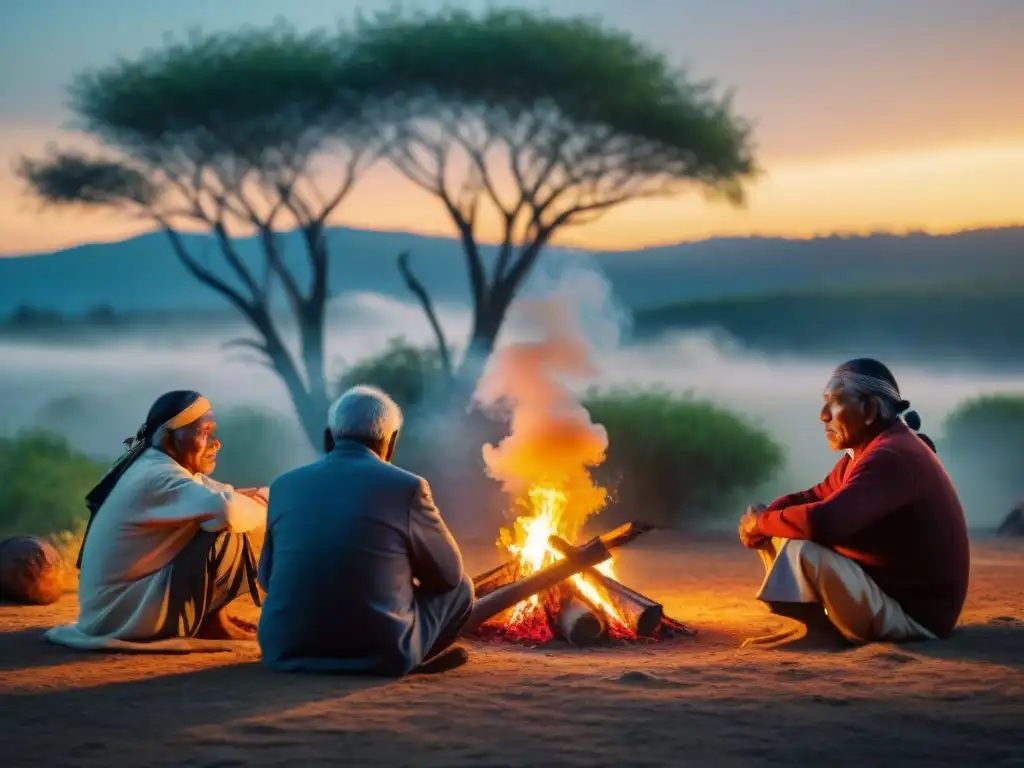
[0,535,1024,768]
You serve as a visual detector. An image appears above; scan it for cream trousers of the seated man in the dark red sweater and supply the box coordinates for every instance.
[757,539,936,643]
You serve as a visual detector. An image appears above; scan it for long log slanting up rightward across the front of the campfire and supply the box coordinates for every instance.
[463,523,626,634]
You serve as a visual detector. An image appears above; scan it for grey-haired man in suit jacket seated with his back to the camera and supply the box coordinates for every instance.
[258,387,473,676]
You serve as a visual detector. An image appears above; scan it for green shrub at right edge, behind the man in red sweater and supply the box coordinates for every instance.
[937,394,1024,525]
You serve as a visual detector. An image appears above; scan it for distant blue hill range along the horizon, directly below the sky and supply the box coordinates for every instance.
[0,227,1024,314]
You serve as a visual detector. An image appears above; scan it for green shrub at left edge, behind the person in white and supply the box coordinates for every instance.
[0,430,106,537]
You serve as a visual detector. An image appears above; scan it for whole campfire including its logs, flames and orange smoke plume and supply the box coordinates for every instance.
[467,297,690,645]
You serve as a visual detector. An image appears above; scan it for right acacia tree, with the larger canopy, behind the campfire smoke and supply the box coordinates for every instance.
[346,9,755,385]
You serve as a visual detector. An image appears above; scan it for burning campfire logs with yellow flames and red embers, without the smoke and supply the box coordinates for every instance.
[473,487,692,646]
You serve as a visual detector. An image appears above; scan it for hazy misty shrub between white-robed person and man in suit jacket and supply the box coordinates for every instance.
[213,406,314,487]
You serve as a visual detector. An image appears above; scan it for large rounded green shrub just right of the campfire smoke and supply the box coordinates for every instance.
[584,390,784,525]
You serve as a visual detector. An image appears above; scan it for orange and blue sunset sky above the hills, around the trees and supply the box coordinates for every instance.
[0,0,1024,259]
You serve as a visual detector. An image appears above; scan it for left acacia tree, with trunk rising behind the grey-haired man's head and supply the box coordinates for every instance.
[19,26,380,444]
